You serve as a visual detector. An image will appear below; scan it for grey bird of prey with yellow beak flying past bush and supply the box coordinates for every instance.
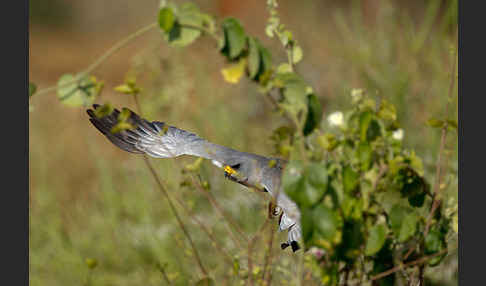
[87,104,301,252]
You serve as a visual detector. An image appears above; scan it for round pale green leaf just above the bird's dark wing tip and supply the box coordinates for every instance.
[57,74,98,107]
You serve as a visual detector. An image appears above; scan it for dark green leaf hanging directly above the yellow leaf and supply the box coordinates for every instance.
[221,18,246,60]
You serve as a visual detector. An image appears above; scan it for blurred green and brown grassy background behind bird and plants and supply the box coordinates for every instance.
[29,0,458,285]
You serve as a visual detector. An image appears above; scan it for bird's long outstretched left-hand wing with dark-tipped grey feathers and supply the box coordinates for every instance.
[87,104,265,166]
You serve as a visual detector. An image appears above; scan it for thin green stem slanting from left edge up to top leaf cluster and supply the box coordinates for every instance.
[36,23,157,96]
